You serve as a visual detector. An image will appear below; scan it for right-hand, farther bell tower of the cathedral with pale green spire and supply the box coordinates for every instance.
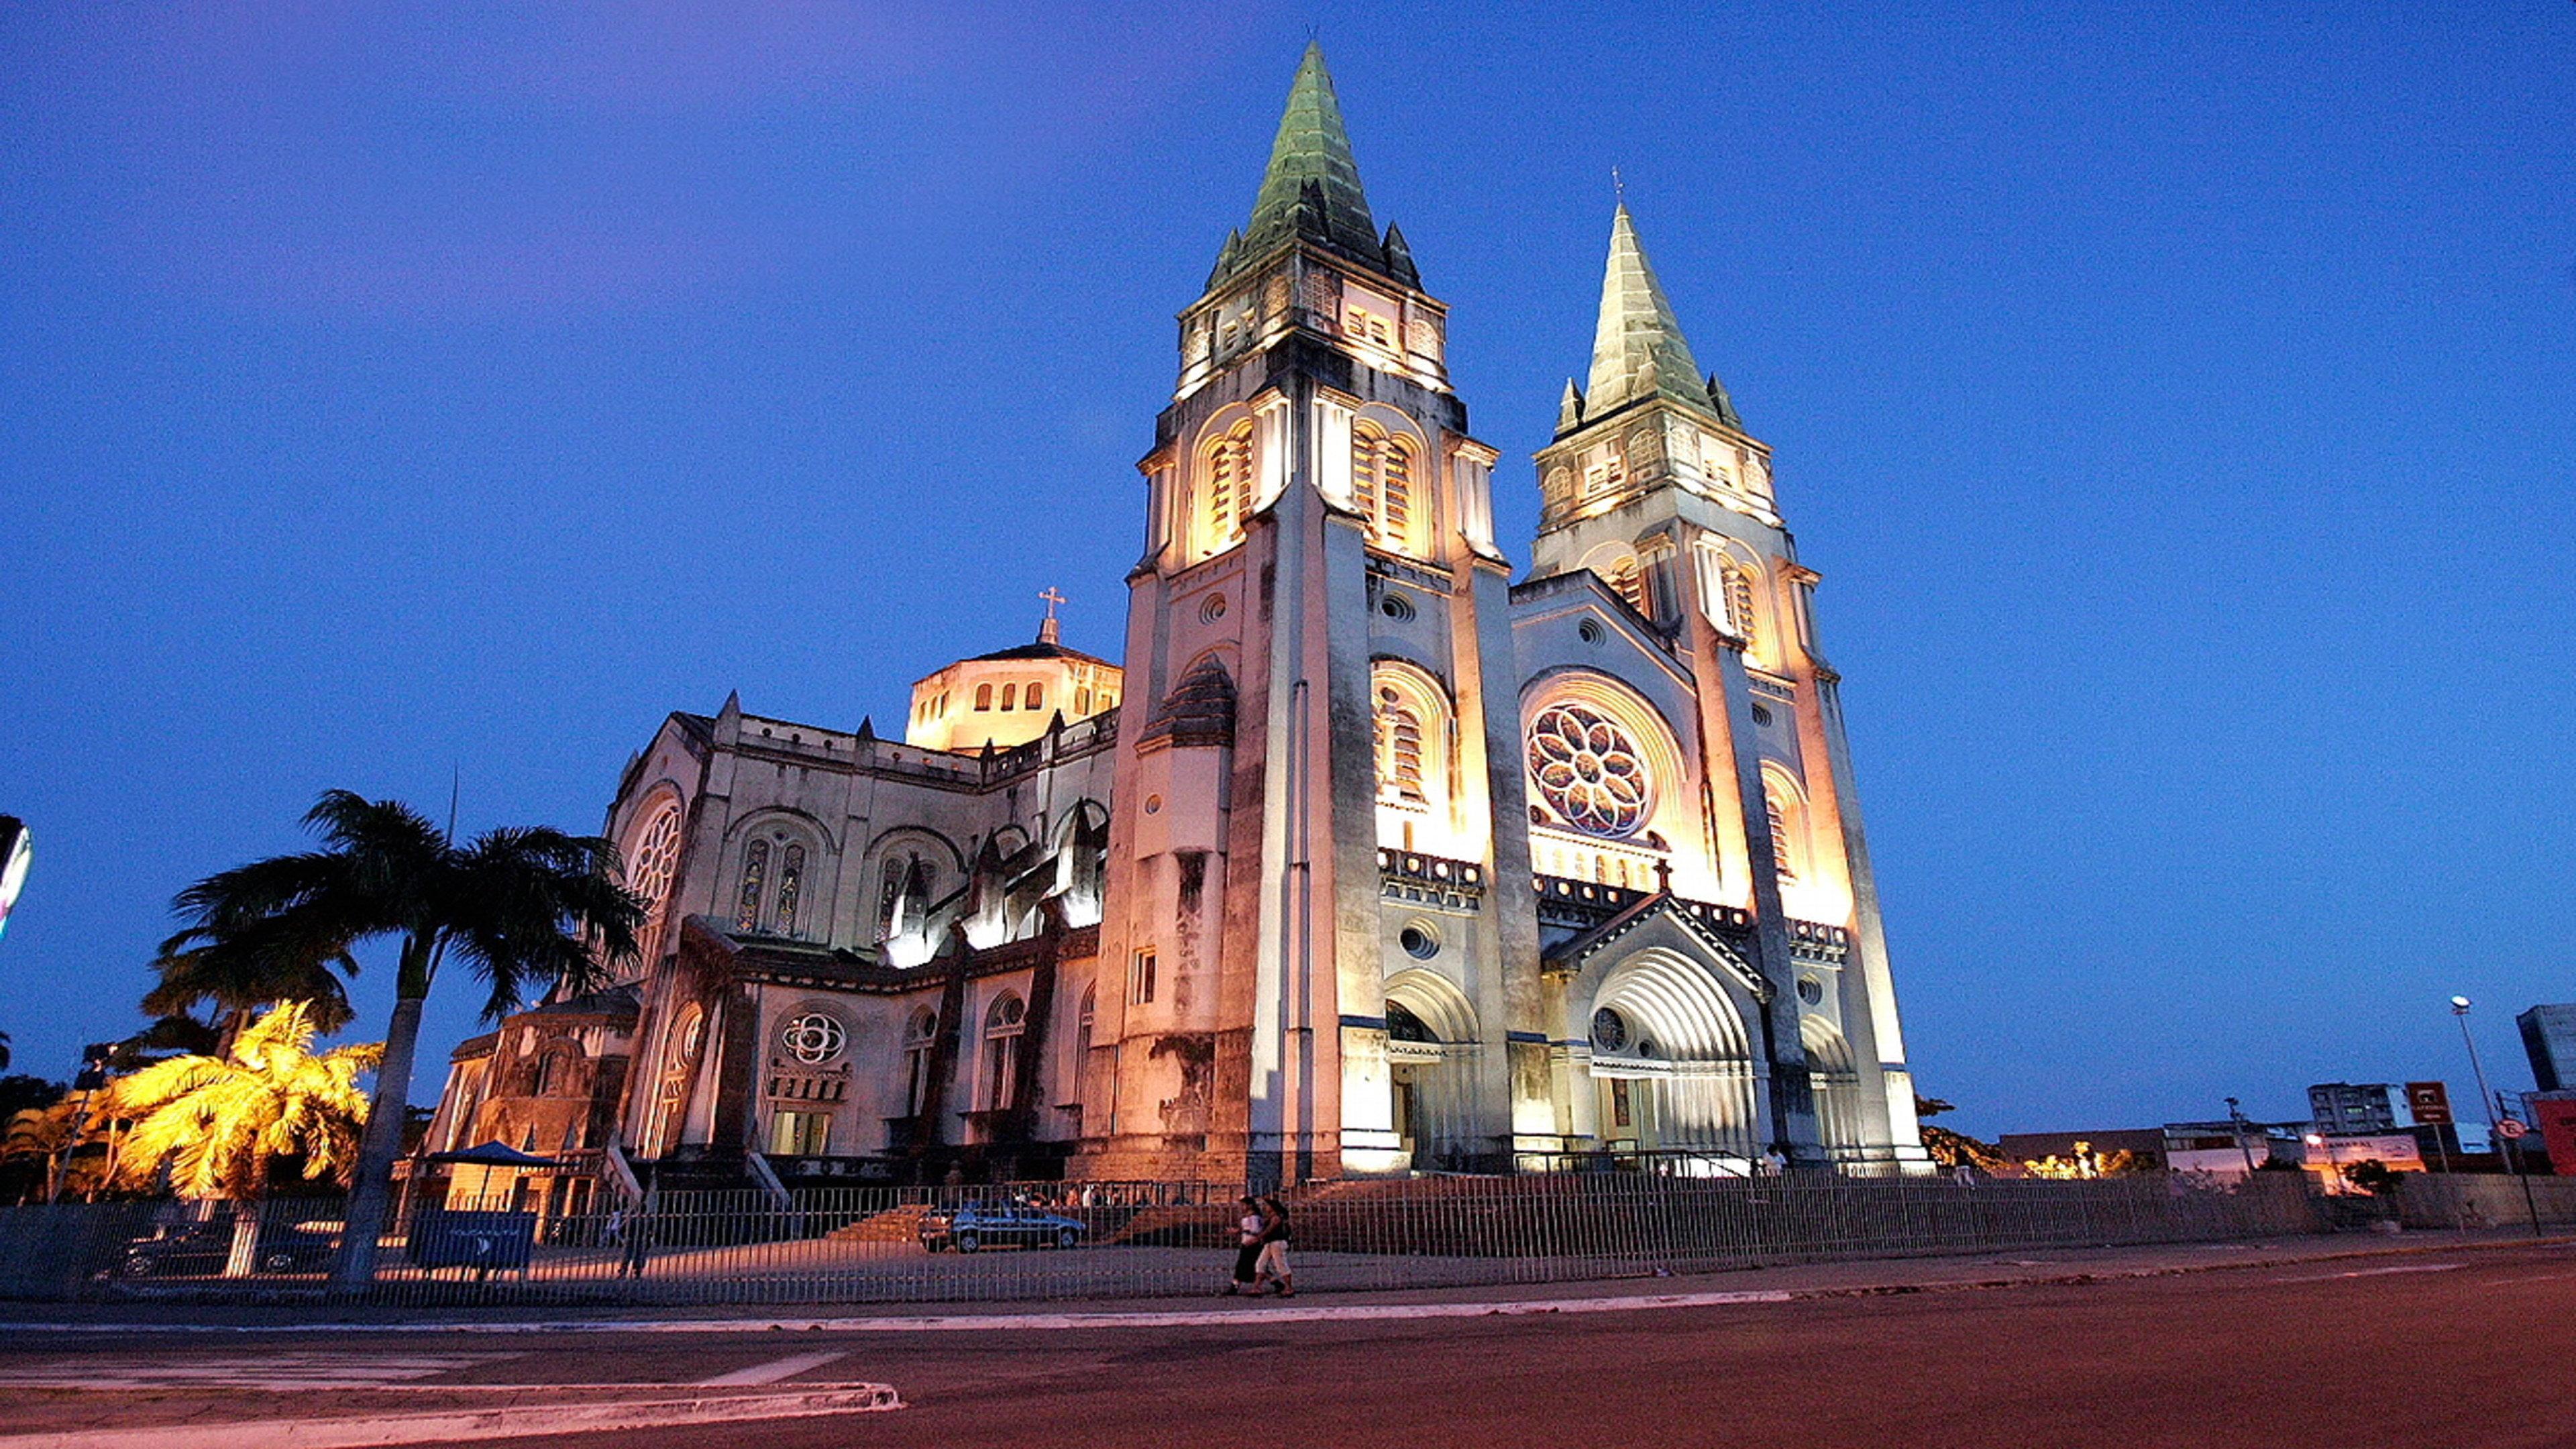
[1530,204,1924,1171]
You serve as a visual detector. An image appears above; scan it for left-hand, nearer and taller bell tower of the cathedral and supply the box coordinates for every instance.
[1074,46,1538,1183]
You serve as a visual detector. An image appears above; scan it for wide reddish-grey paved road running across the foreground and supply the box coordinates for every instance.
[0,1245,2576,1449]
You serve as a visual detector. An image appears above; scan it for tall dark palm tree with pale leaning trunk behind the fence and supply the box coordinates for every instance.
[175,789,644,1289]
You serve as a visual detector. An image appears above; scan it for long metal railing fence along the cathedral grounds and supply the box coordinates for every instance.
[0,1173,2339,1305]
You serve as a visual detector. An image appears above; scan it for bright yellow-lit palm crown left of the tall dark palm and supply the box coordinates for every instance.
[105,1000,384,1201]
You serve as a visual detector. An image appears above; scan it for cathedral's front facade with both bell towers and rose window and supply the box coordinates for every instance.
[1074,49,1927,1181]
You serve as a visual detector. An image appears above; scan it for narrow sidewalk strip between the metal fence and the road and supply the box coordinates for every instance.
[0,1230,2576,1343]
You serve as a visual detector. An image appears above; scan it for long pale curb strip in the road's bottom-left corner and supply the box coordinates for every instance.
[0,1385,904,1449]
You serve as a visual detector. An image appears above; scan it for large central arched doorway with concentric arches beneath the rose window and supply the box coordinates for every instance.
[1582,949,1762,1163]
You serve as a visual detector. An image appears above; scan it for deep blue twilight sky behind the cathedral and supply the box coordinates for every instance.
[0,0,2576,1132]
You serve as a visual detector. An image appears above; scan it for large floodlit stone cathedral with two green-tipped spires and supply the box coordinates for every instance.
[430,46,1929,1210]
